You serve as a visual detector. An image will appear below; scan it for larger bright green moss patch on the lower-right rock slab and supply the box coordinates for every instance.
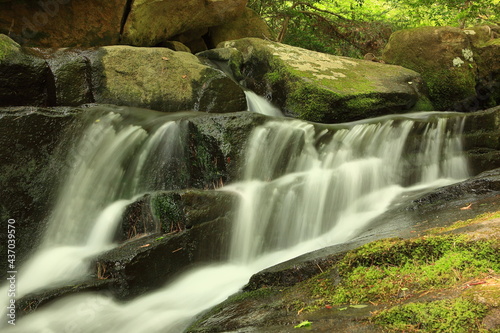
[298,235,500,307]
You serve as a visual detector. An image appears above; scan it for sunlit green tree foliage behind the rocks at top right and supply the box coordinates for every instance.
[248,0,500,57]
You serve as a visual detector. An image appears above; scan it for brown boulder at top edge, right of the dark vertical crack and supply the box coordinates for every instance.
[122,0,246,46]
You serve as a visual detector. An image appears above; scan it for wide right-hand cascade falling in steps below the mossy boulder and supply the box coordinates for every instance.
[230,114,467,262]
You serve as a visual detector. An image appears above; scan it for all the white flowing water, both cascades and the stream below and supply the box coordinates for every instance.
[0,95,468,333]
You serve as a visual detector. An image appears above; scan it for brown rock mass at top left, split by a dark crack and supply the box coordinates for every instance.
[0,0,247,48]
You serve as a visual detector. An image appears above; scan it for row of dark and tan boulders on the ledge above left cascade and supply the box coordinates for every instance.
[0,35,247,113]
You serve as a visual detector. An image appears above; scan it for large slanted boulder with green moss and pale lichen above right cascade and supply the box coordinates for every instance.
[211,38,431,123]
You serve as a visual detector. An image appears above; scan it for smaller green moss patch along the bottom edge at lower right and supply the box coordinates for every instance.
[373,298,487,333]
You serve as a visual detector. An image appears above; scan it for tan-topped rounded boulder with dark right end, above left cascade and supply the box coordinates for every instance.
[94,46,246,112]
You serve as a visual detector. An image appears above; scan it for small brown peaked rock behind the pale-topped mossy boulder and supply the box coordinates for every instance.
[208,8,273,48]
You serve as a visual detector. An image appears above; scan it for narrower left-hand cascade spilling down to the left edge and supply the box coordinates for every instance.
[3,109,186,297]
